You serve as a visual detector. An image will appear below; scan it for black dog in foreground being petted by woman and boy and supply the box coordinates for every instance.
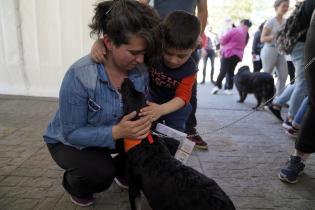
[121,79,235,210]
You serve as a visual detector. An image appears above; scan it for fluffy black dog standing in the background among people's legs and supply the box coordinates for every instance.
[234,66,275,109]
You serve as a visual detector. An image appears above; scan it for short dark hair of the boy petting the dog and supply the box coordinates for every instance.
[161,11,201,49]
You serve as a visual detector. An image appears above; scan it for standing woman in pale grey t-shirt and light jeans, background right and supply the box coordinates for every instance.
[260,0,289,96]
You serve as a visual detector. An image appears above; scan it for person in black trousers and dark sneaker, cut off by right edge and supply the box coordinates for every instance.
[279,0,315,183]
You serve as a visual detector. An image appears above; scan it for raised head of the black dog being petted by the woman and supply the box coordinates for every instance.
[121,78,146,119]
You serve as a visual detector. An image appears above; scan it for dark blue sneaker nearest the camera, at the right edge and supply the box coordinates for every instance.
[279,155,305,184]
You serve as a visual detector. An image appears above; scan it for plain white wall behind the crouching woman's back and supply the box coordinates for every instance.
[0,0,96,96]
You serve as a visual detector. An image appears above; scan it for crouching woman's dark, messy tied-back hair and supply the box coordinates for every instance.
[89,0,160,64]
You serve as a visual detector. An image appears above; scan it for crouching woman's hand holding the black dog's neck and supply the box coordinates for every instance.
[112,111,151,139]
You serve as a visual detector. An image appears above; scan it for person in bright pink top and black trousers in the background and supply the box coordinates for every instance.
[211,19,252,95]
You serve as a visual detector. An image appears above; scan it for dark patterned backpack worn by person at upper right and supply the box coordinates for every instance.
[276,2,307,55]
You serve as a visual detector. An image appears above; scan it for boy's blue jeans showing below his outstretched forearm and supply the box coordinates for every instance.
[157,104,192,132]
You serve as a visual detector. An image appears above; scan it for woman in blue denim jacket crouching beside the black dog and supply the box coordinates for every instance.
[44,0,159,206]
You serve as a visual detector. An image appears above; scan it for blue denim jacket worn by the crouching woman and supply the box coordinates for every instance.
[44,56,148,149]
